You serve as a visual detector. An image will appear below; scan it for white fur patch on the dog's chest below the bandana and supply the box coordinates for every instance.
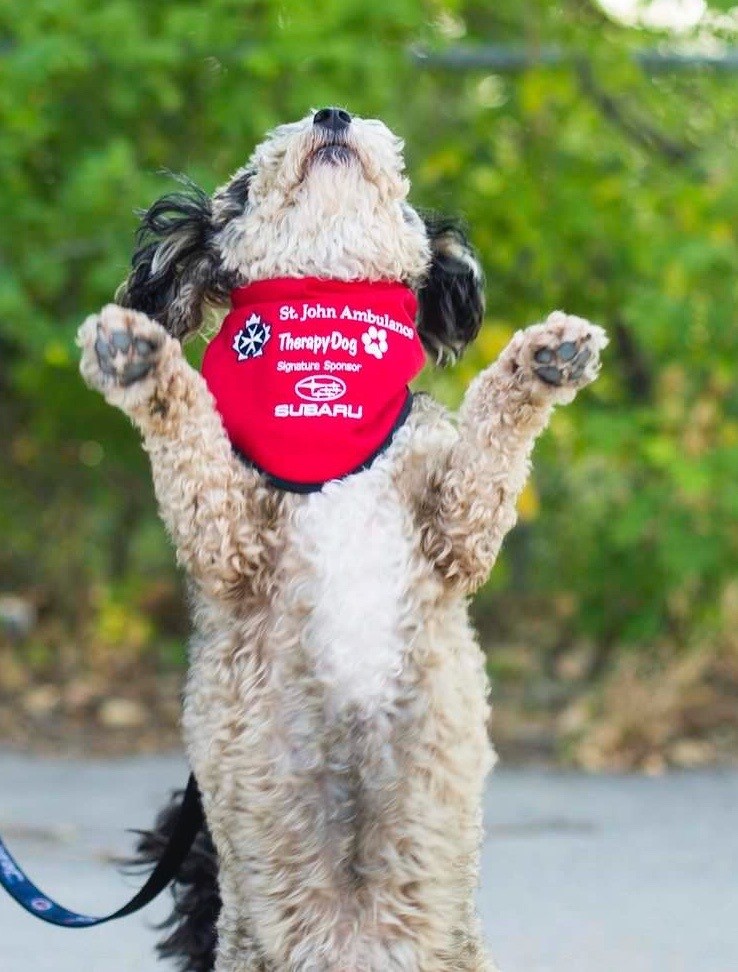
[294,470,411,709]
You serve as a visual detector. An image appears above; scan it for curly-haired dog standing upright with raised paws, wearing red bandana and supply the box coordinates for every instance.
[78,108,606,972]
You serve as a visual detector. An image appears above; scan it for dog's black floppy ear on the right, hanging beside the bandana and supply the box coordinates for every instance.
[418,214,484,364]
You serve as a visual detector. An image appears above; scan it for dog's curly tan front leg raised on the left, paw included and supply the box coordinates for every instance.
[77,304,279,601]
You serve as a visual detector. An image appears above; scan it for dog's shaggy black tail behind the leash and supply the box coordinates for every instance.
[126,791,220,972]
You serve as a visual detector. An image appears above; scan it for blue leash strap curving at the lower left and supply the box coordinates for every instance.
[0,775,205,928]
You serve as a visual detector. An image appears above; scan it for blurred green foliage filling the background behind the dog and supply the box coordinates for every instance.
[0,0,738,660]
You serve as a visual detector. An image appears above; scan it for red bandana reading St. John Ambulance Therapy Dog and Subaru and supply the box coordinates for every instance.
[202,277,424,487]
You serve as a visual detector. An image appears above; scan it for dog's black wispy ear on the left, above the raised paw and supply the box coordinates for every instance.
[117,177,242,340]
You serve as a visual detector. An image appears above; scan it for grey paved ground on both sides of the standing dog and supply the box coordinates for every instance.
[0,754,738,972]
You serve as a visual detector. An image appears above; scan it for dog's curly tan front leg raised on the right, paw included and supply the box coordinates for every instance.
[421,311,607,593]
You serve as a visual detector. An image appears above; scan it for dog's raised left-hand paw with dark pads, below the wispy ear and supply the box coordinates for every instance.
[79,304,165,388]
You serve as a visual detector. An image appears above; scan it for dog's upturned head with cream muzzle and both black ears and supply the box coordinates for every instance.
[119,108,484,361]
